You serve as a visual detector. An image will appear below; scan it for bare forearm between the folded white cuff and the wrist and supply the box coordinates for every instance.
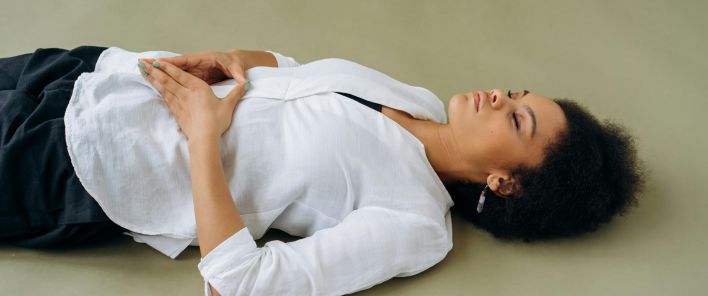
[189,136,245,257]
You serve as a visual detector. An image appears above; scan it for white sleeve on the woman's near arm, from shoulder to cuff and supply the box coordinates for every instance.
[198,207,452,296]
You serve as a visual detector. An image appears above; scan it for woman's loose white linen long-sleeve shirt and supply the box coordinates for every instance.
[65,47,452,295]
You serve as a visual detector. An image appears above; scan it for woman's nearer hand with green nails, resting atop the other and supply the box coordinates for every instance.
[138,59,250,140]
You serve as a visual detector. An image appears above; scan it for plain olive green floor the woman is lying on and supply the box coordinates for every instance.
[0,0,708,295]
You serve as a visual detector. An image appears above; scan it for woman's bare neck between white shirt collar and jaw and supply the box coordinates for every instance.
[407,119,485,183]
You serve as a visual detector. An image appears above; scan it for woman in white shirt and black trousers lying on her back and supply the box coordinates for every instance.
[0,47,642,295]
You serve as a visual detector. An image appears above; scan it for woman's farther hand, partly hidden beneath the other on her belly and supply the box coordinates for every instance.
[143,50,247,85]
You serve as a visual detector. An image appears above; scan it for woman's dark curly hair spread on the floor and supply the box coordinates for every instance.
[445,99,645,242]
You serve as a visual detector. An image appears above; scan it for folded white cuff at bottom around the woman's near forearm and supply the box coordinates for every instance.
[197,227,258,295]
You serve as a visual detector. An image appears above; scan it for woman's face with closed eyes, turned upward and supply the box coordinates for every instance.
[448,89,566,184]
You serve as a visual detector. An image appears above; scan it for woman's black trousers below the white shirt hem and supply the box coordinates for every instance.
[0,46,125,248]
